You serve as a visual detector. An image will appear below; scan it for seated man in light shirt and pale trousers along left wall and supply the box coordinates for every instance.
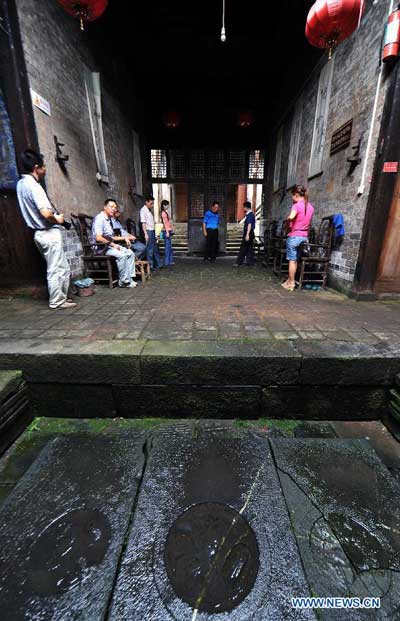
[92,198,137,289]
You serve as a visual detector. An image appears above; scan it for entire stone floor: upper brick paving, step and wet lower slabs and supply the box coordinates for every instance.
[0,260,400,621]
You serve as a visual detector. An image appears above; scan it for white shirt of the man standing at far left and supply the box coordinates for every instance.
[17,175,57,231]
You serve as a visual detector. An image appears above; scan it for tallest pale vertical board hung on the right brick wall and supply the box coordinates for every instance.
[308,57,335,177]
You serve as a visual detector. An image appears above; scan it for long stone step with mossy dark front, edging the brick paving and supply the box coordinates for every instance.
[0,339,400,420]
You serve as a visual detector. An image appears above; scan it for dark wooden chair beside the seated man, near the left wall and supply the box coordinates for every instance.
[71,213,118,289]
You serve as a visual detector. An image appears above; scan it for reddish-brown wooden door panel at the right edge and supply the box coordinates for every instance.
[375,173,400,293]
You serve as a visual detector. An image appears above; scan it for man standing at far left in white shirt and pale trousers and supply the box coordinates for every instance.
[17,149,76,309]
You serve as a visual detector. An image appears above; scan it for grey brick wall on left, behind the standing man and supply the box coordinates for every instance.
[17,0,146,275]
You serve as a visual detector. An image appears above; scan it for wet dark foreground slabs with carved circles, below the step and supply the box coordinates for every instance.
[0,422,400,621]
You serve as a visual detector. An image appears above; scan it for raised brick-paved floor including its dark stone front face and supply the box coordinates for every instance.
[0,260,400,419]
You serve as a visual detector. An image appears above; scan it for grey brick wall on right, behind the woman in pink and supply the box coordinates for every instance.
[266,0,389,290]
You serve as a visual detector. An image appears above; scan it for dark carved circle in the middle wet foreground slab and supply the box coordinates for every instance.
[164,503,259,613]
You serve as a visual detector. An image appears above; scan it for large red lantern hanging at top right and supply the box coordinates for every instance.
[306,0,365,57]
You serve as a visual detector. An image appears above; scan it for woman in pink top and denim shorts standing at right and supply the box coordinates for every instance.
[282,185,314,291]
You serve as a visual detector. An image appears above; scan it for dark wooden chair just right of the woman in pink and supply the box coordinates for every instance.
[296,216,334,289]
